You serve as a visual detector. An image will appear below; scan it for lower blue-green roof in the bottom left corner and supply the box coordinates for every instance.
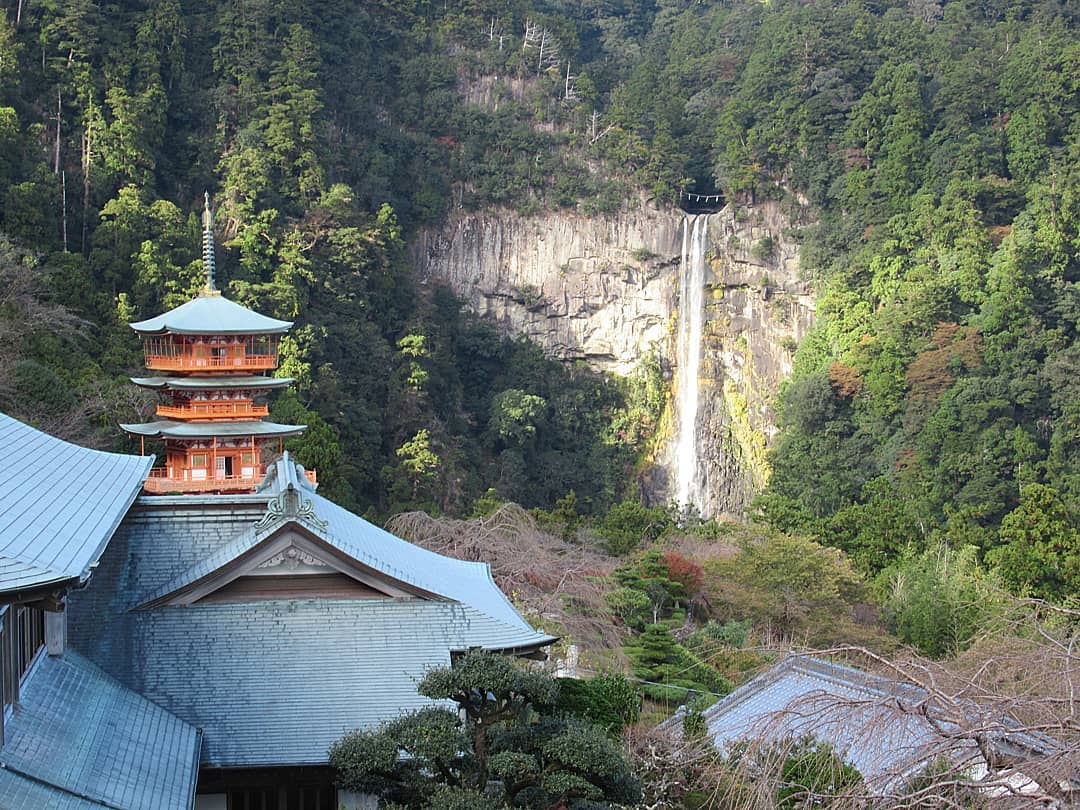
[0,652,201,810]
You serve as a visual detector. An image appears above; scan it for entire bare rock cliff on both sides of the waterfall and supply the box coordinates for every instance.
[411,202,813,514]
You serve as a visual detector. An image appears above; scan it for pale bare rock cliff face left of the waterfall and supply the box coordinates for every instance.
[413,199,681,374]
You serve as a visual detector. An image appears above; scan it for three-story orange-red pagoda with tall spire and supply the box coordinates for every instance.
[120,194,306,495]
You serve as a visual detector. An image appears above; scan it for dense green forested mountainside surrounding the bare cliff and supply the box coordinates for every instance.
[0,0,1080,596]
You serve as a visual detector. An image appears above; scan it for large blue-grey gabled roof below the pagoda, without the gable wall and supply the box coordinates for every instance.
[69,459,554,767]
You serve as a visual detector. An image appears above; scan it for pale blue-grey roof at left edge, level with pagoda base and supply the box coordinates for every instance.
[0,414,153,593]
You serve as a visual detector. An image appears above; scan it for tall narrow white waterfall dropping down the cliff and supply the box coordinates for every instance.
[675,214,708,512]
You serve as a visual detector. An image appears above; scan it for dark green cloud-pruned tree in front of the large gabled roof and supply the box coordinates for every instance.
[329,650,639,809]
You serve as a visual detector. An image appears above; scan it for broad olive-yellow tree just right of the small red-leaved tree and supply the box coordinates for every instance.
[704,532,865,639]
